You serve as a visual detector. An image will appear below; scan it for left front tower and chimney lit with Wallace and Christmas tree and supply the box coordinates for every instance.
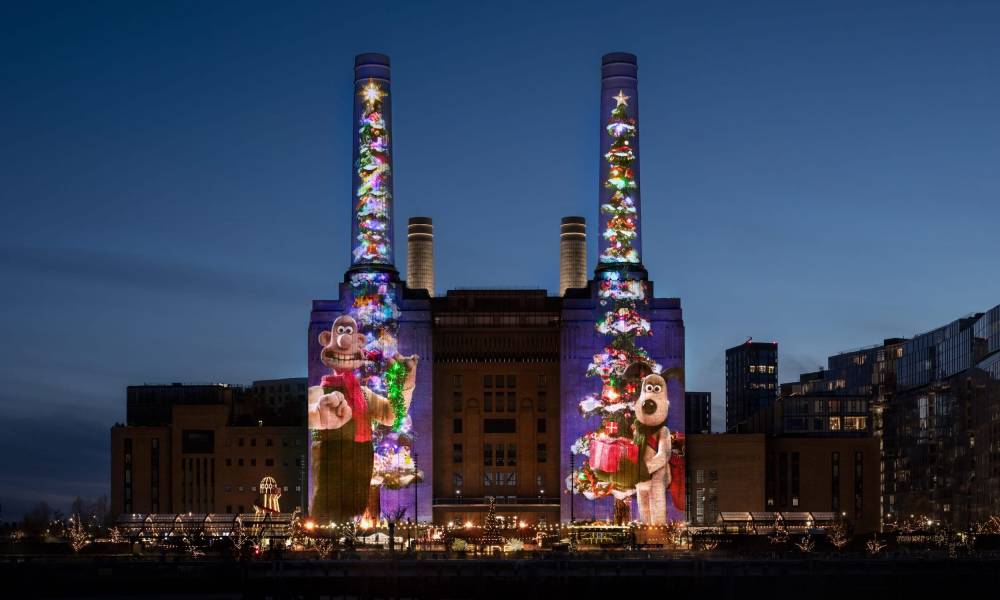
[308,54,426,522]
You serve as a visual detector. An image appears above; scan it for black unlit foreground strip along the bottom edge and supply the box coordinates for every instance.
[0,555,1000,600]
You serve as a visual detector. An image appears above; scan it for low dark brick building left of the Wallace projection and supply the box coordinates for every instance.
[111,378,307,515]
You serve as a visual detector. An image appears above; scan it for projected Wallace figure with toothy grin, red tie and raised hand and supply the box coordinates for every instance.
[309,315,419,522]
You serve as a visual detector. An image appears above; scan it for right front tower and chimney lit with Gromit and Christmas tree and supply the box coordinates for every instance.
[560,52,687,524]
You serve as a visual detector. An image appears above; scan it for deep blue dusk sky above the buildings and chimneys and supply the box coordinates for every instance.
[0,0,1000,520]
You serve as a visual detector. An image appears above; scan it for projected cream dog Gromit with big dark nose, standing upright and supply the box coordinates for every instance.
[633,373,671,525]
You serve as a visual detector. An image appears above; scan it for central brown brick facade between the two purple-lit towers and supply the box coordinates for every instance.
[432,290,561,523]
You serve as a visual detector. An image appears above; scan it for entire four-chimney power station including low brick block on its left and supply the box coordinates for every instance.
[112,53,688,525]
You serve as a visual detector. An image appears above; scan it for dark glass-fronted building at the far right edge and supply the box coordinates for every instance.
[884,306,1000,528]
